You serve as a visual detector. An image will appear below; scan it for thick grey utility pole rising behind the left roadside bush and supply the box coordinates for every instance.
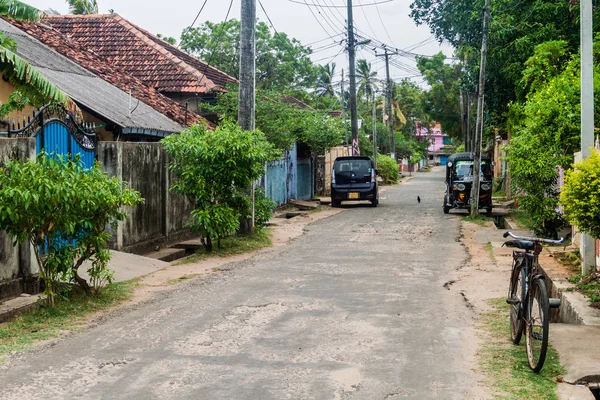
[238,0,256,234]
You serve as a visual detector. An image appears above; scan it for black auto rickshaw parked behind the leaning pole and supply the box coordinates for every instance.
[444,153,493,215]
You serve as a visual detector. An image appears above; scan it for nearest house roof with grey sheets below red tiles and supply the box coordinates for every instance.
[0,20,208,141]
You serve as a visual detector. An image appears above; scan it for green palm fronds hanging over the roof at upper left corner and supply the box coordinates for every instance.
[0,0,69,116]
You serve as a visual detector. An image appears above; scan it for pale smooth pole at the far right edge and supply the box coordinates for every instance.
[579,0,596,276]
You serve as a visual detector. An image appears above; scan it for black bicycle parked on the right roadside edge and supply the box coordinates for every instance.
[503,231,564,373]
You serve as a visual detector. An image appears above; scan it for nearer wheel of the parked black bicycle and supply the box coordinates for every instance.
[525,279,550,373]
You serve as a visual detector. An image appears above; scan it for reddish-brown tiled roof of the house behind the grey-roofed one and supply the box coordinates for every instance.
[43,14,238,121]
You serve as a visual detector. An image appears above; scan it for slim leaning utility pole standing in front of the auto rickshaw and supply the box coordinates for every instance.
[471,0,491,216]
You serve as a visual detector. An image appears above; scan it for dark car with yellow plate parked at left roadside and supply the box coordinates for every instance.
[331,156,379,207]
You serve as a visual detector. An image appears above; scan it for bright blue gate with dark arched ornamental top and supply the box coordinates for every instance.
[8,104,97,168]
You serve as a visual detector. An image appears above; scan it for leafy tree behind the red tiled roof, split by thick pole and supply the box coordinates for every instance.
[180,20,318,90]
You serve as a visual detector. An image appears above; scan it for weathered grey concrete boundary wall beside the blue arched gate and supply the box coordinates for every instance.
[0,138,194,300]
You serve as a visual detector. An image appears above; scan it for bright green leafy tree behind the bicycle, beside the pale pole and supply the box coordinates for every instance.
[507,41,600,236]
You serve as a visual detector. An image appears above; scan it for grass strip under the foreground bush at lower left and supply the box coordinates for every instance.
[0,280,137,355]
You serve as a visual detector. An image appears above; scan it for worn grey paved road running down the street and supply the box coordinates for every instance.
[0,167,474,400]
